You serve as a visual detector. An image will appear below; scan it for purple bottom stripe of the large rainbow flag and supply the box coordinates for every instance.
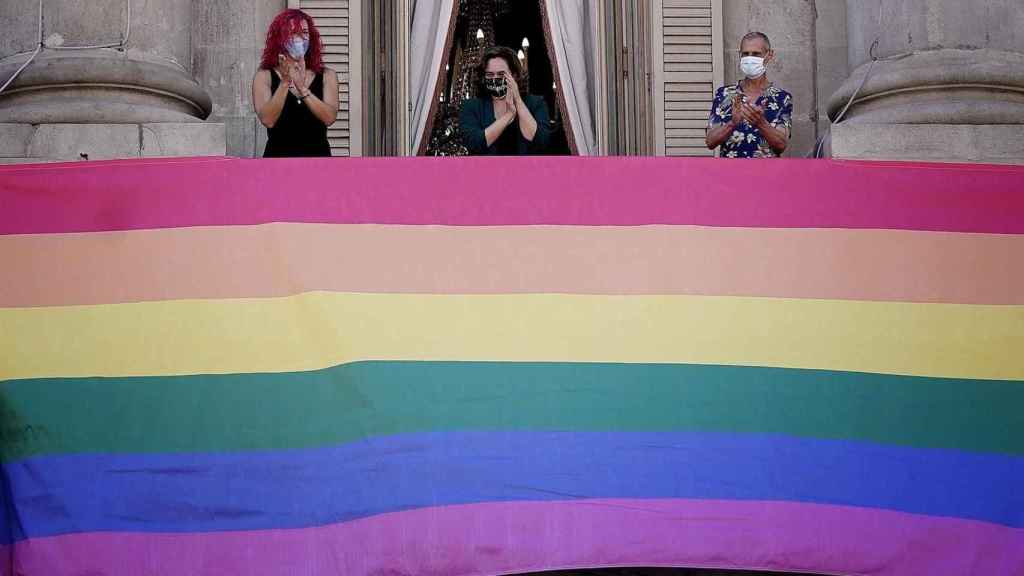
[9,500,1024,576]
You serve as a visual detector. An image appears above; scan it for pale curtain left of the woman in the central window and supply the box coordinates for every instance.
[409,0,455,154]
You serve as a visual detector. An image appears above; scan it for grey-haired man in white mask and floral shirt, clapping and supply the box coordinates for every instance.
[707,32,793,158]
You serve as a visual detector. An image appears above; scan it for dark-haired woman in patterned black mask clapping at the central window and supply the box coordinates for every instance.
[459,46,551,156]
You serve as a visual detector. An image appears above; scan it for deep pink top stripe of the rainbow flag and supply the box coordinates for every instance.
[0,157,1024,234]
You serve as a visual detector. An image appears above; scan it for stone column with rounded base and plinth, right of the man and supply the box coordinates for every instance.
[828,0,1024,163]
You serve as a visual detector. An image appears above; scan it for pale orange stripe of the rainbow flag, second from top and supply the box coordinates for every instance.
[0,223,1024,306]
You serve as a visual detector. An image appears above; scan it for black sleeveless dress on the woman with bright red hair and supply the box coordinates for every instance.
[263,70,331,158]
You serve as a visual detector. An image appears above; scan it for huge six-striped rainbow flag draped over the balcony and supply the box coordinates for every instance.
[0,158,1024,576]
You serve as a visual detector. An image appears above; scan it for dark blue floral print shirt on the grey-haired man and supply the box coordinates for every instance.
[708,84,793,158]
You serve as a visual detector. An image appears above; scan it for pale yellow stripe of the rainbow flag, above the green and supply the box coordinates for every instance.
[0,292,1024,379]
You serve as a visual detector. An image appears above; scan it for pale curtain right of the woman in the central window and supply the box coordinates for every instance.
[544,0,598,156]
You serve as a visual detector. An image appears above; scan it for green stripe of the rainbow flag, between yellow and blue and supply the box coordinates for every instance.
[0,362,1024,459]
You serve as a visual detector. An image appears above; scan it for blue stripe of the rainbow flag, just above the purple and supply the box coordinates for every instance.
[4,422,1024,539]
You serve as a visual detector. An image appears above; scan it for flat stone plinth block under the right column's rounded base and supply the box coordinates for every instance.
[831,122,1024,165]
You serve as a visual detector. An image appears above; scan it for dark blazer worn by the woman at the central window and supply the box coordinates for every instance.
[459,95,551,156]
